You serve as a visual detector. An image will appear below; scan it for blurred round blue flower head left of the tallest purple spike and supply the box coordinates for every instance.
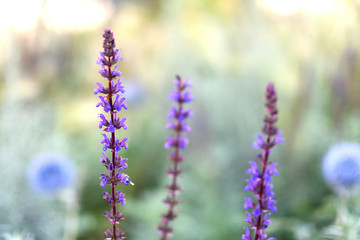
[28,153,75,193]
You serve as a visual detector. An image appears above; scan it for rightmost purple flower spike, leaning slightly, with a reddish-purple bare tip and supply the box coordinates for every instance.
[242,83,284,240]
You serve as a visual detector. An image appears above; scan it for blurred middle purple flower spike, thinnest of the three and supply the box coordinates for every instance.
[158,76,193,240]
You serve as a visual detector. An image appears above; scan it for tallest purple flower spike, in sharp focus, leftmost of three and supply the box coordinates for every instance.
[94,29,134,240]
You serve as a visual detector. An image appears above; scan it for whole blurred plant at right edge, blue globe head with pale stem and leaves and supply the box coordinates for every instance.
[322,142,360,240]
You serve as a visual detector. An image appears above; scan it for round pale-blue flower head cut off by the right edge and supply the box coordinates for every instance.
[322,143,360,190]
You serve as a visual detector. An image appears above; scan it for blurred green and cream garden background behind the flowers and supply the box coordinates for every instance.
[0,0,360,240]
